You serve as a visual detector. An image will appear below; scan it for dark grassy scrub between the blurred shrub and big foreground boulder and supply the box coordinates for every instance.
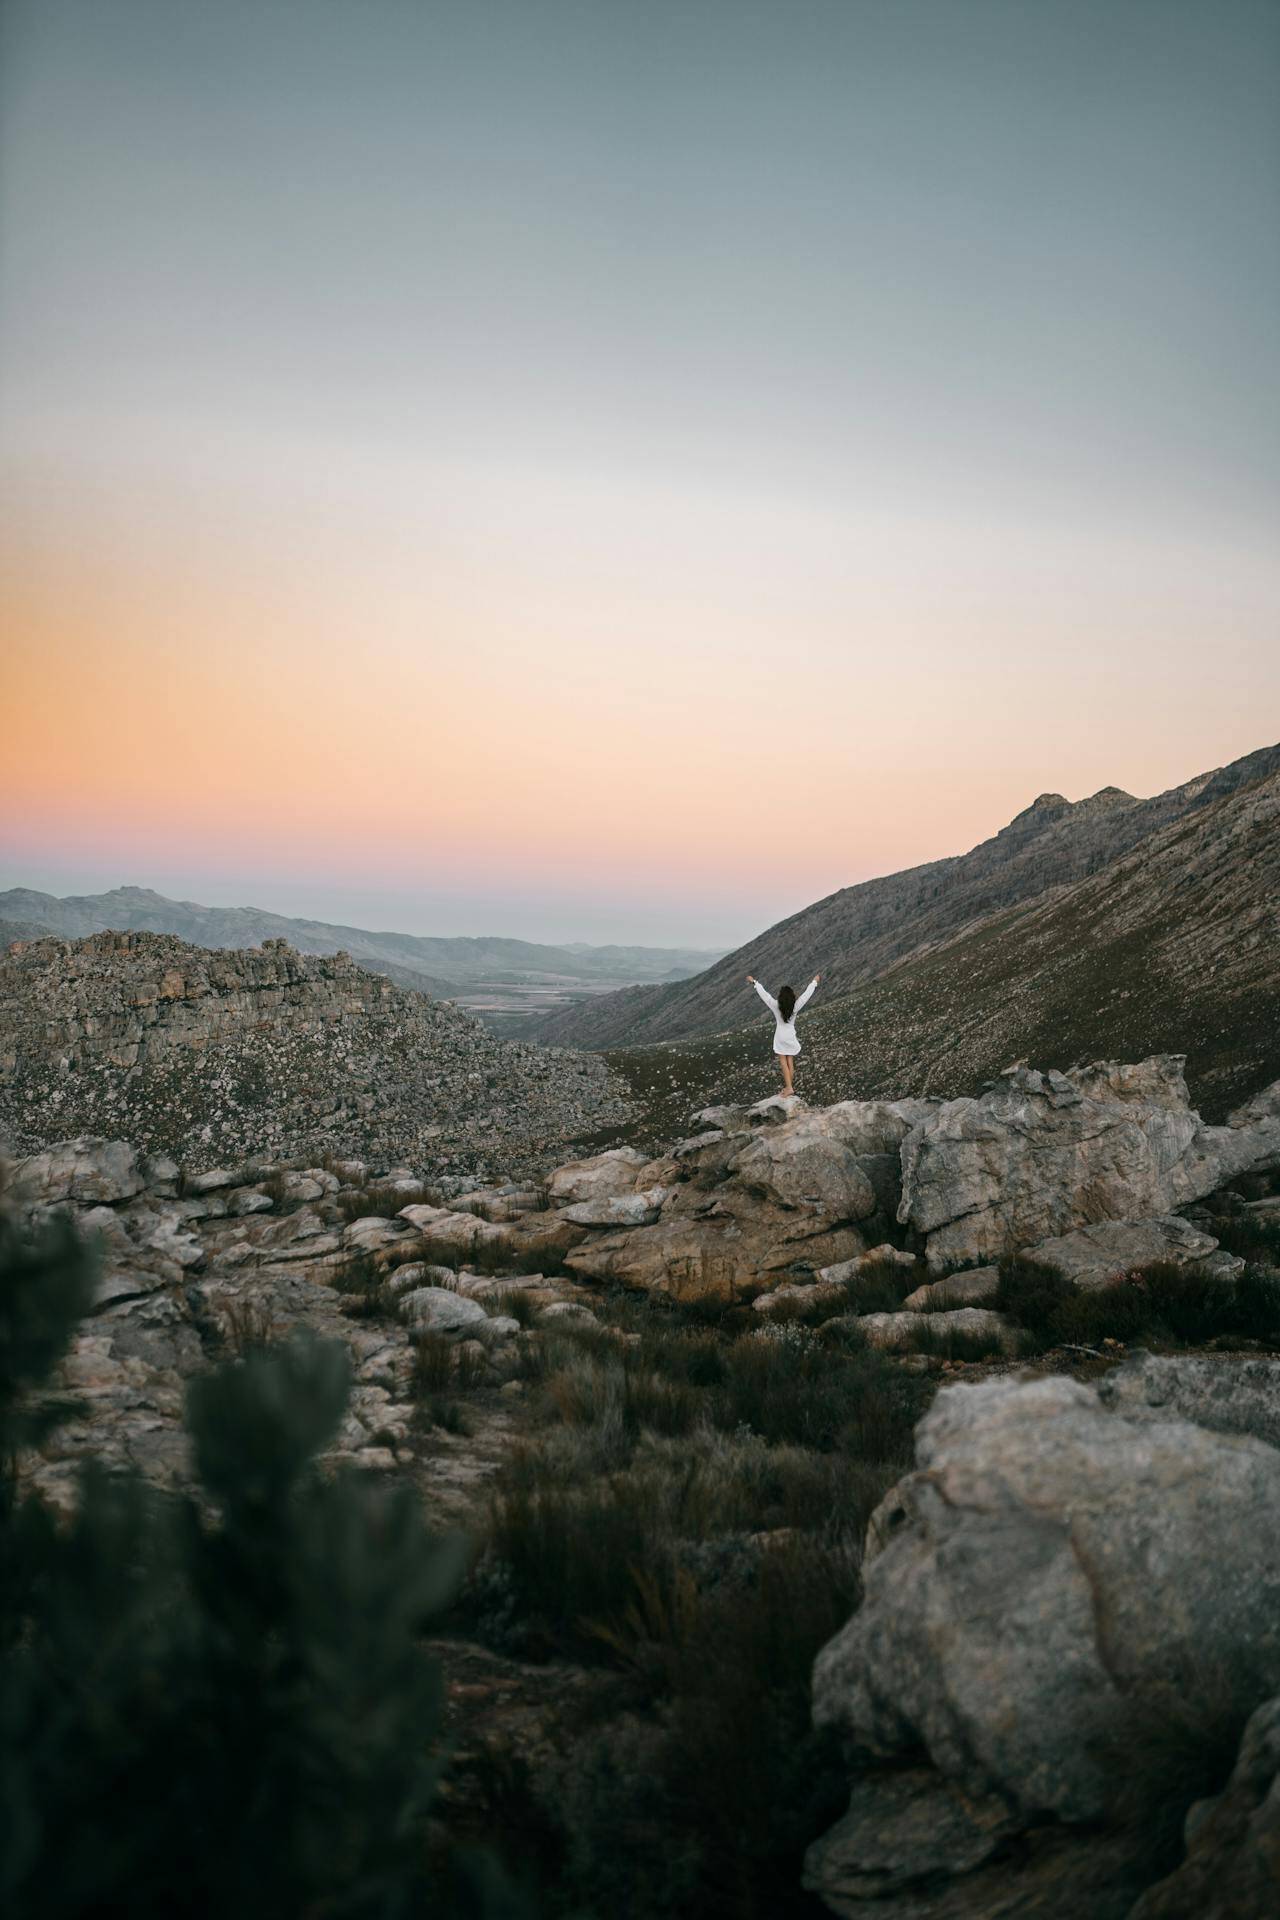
[457,1300,931,1920]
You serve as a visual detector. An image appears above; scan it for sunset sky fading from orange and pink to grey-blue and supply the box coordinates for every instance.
[0,0,1280,947]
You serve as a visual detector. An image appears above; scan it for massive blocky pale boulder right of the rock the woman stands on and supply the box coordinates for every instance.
[898,1054,1280,1267]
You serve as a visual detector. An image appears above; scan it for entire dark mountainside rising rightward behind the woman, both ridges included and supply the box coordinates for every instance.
[526,729,1280,1125]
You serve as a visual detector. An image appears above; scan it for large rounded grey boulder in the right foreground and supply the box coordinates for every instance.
[814,1377,1280,1822]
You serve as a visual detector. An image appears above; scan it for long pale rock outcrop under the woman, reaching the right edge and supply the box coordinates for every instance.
[541,1056,1280,1305]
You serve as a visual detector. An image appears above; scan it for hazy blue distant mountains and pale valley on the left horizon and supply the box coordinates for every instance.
[0,887,714,1023]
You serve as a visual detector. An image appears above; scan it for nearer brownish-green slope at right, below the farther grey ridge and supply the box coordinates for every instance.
[604,772,1280,1137]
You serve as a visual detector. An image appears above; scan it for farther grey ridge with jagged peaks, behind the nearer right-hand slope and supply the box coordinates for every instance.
[526,745,1280,1048]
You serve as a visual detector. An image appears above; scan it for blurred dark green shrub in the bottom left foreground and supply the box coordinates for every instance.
[0,1223,503,1920]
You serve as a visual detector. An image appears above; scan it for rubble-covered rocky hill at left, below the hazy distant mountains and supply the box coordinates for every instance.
[0,933,626,1171]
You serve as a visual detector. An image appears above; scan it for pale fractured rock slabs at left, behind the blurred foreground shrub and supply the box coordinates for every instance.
[4,1139,595,1515]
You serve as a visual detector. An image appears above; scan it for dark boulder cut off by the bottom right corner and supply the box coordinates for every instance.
[1130,1695,1280,1920]
